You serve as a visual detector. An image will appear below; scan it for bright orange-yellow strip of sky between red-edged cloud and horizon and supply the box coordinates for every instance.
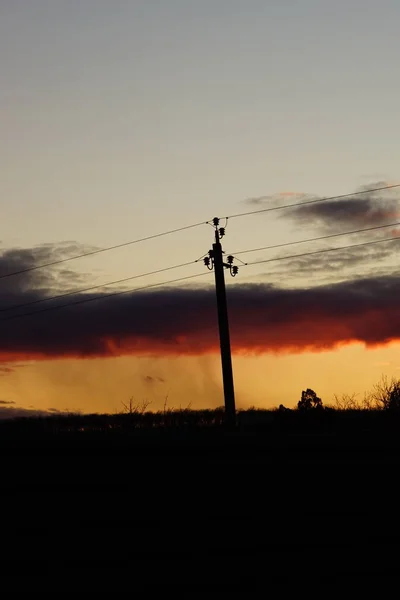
[0,343,400,412]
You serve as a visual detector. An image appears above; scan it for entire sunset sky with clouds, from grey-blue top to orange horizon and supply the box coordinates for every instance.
[0,0,400,416]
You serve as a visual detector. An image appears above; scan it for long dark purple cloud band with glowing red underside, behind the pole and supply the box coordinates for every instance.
[0,239,400,360]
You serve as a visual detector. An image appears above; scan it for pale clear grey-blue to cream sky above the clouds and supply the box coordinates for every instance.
[0,0,400,412]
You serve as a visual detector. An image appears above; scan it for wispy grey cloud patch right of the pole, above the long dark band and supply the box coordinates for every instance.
[241,182,400,282]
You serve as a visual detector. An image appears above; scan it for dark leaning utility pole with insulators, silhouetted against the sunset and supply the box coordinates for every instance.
[204,217,239,425]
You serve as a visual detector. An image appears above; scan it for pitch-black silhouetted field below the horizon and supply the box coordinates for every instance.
[0,411,400,595]
